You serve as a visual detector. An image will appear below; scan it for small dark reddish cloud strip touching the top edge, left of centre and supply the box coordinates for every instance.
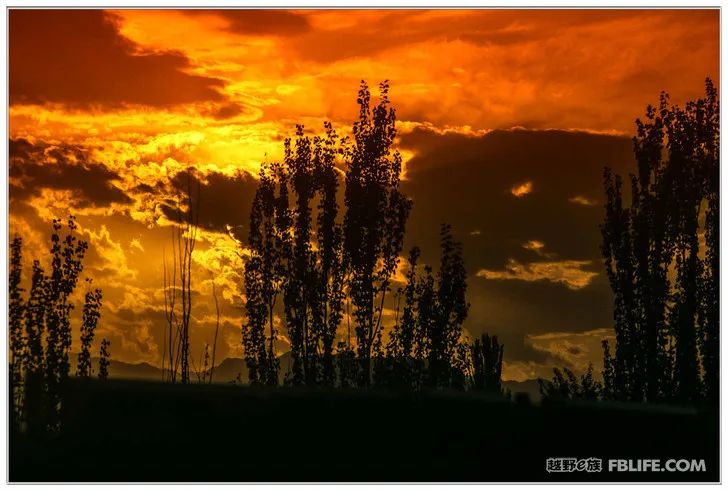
[182,9,310,36]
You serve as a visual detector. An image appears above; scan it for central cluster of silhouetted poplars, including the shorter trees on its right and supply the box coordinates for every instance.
[243,82,503,393]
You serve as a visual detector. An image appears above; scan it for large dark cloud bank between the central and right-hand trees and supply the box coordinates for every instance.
[401,130,634,363]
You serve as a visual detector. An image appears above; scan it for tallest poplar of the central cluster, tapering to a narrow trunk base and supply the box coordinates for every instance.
[344,82,411,387]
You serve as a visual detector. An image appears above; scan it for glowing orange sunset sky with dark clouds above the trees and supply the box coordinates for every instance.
[9,9,719,380]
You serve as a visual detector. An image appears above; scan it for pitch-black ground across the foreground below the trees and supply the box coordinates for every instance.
[9,380,719,482]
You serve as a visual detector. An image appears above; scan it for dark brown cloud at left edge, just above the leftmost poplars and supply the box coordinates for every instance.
[9,138,131,208]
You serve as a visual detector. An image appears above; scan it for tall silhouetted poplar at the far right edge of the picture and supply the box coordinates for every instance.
[666,80,720,400]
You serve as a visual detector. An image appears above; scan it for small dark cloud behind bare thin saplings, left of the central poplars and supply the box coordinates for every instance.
[163,172,258,240]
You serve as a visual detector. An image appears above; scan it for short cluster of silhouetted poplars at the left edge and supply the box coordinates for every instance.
[8,216,111,436]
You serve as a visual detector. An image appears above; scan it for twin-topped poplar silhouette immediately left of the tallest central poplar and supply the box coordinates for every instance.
[284,123,344,385]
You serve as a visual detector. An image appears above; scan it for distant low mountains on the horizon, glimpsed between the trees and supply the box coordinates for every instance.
[73,353,541,401]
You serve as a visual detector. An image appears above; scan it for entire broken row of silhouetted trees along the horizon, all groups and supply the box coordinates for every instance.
[8,80,719,414]
